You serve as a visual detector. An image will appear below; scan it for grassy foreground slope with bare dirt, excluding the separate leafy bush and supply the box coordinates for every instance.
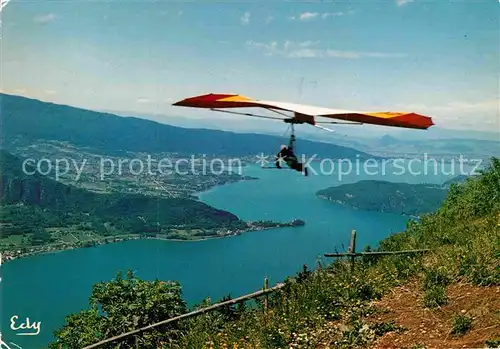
[168,159,500,348]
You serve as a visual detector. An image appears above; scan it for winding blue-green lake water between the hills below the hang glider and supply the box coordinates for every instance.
[0,160,470,349]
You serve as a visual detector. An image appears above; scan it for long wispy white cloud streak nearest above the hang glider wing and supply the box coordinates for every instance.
[246,40,406,59]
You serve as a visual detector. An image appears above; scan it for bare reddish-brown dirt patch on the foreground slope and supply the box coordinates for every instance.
[369,283,500,349]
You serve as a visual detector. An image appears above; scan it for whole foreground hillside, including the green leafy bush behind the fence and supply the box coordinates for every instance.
[47,159,500,349]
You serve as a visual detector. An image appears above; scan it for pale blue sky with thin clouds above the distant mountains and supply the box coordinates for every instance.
[0,0,500,136]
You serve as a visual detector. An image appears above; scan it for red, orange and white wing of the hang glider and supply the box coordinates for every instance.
[173,93,434,130]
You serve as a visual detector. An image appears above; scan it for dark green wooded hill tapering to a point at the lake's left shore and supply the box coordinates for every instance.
[0,151,246,244]
